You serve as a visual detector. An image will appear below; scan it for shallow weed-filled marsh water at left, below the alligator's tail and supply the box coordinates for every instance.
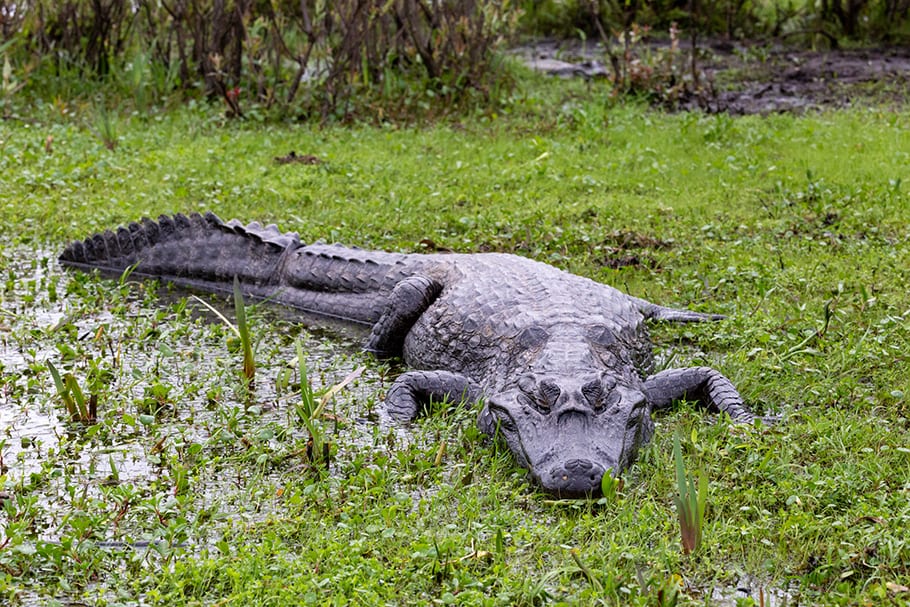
[0,247,420,543]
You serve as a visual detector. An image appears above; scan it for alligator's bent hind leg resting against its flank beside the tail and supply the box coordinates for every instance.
[363,276,442,358]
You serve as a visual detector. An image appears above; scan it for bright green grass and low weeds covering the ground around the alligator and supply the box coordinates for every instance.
[0,81,910,605]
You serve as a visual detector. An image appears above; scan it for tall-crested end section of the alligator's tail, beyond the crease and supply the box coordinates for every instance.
[60,213,303,297]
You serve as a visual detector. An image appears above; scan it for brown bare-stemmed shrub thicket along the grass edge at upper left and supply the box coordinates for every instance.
[7,0,518,116]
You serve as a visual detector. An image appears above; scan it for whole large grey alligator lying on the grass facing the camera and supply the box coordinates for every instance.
[60,213,755,497]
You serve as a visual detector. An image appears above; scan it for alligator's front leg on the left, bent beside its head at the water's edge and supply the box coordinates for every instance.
[386,371,482,421]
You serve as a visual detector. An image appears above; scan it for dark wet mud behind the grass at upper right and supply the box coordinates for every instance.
[516,41,910,115]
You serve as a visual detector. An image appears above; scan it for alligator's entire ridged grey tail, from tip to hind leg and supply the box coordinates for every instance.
[60,213,428,326]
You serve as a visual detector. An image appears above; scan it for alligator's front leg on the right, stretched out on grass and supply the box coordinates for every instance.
[644,367,756,423]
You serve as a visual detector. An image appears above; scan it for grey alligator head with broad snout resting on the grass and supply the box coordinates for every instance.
[480,373,654,497]
